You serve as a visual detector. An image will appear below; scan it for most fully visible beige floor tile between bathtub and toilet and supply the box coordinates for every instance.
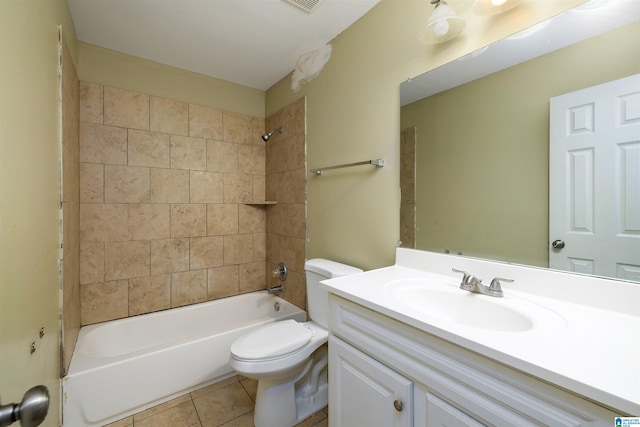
[193,382,254,427]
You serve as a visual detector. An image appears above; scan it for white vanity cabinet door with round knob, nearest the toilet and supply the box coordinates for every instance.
[329,336,413,427]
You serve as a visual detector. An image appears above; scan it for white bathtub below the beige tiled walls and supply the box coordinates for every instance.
[62,291,306,427]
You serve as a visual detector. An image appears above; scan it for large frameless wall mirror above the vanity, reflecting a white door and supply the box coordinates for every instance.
[400,0,640,282]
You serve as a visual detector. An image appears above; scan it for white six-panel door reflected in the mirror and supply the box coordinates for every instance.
[549,74,640,282]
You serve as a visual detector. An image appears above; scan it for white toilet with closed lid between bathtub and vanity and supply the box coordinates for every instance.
[229,258,362,427]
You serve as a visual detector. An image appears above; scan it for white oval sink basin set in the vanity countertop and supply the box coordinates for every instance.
[387,280,565,332]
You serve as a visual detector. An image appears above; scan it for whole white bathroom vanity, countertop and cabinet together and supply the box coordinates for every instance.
[323,249,640,427]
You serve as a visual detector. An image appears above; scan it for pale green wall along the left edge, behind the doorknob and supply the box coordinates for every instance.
[0,0,77,426]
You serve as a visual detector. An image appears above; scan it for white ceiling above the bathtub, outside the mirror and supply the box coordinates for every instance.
[67,0,380,90]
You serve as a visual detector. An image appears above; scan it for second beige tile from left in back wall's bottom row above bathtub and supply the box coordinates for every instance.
[129,274,171,316]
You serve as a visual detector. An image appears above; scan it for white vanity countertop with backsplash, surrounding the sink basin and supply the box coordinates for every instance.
[322,249,640,416]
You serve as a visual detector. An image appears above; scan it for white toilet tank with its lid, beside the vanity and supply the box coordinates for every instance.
[304,258,363,328]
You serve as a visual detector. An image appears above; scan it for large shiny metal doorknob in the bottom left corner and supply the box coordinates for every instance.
[0,385,49,427]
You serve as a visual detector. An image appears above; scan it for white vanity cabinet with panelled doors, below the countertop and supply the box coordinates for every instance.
[329,294,616,427]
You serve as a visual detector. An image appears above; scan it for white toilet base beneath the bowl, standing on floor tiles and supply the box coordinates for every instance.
[253,344,329,427]
